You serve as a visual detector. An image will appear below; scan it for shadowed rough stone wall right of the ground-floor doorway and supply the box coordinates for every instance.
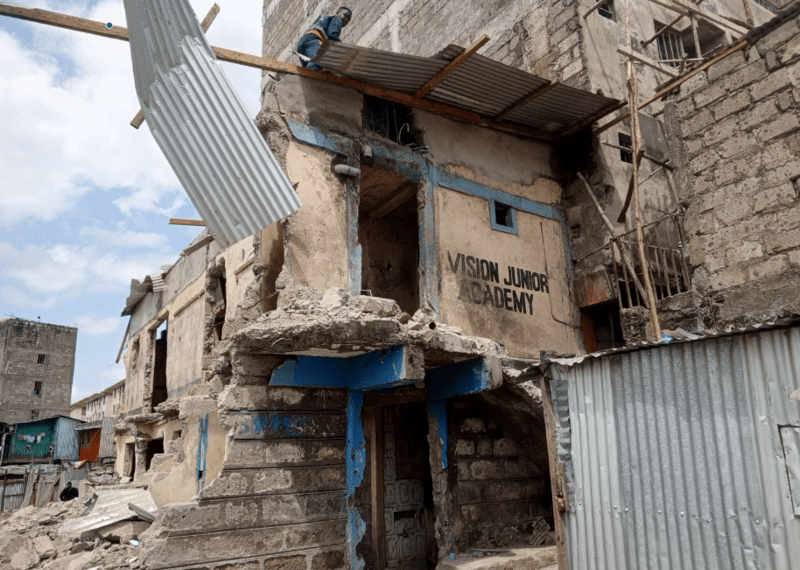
[448,390,553,552]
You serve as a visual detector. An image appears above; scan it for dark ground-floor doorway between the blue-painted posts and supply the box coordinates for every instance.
[356,401,437,570]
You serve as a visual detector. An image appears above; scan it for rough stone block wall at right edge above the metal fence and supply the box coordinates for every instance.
[667,14,800,327]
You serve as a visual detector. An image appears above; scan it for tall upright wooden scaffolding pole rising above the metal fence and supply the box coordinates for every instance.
[625,0,661,341]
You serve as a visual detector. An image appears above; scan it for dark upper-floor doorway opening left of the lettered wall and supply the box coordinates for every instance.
[358,165,420,314]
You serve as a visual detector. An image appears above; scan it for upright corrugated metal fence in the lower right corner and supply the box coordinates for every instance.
[549,327,800,570]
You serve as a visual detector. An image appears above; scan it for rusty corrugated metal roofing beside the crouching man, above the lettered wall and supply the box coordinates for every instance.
[314,42,617,132]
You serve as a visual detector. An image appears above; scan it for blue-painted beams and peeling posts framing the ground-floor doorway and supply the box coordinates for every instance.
[270,346,498,570]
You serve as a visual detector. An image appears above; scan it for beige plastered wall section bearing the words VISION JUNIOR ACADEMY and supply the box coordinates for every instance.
[436,187,580,358]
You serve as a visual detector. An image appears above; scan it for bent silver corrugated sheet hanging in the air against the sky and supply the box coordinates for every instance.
[124,0,300,248]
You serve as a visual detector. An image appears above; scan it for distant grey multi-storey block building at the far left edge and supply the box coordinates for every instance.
[0,317,78,424]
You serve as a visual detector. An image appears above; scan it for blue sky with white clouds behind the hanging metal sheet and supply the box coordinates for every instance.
[0,0,263,402]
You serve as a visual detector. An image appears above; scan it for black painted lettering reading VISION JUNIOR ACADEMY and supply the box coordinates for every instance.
[447,251,550,315]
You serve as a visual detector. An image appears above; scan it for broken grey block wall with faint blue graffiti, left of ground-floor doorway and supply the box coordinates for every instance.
[143,380,347,570]
